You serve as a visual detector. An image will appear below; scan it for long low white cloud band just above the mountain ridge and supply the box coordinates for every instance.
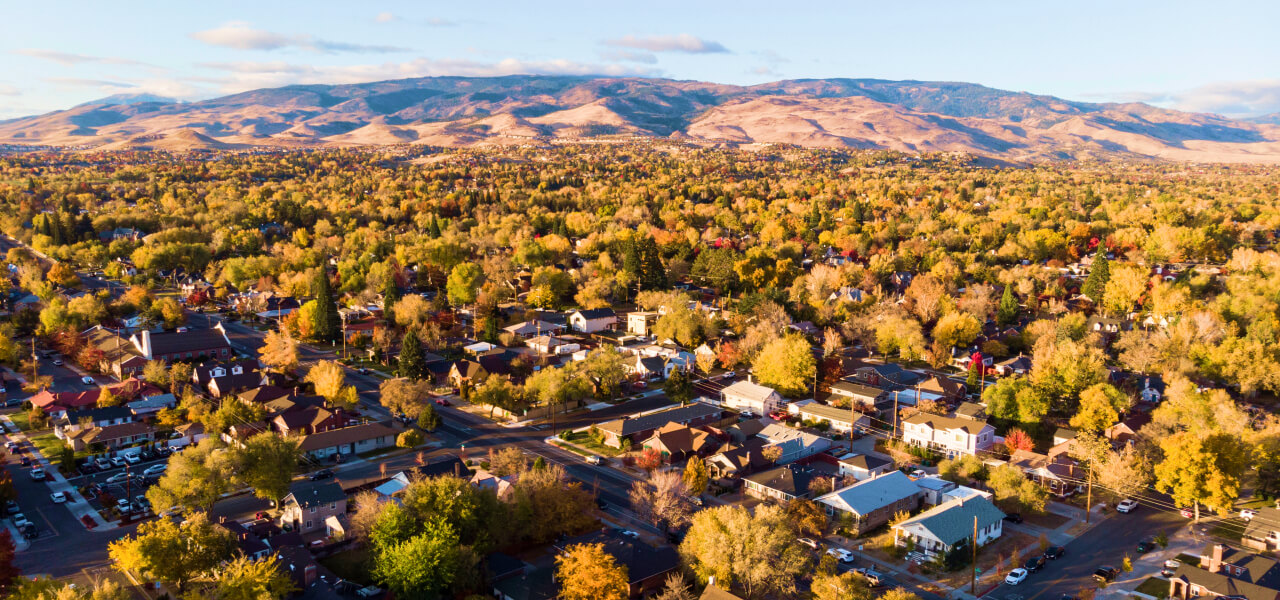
[200,58,660,93]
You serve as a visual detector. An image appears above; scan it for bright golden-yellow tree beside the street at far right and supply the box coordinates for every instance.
[1155,431,1249,519]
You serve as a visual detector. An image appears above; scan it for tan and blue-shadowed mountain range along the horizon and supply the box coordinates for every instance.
[0,75,1280,162]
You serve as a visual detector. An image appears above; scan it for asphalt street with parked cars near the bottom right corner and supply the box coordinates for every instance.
[986,507,1187,600]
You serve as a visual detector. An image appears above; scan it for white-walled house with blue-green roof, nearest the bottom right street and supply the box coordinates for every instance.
[893,496,1005,557]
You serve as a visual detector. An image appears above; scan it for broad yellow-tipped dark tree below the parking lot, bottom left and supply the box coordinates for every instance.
[108,513,236,591]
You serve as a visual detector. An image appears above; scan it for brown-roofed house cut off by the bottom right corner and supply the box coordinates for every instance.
[1169,544,1280,600]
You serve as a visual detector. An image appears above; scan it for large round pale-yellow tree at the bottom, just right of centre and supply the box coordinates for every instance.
[680,504,808,597]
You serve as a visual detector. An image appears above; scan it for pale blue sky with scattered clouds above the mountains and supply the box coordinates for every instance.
[0,0,1280,119]
